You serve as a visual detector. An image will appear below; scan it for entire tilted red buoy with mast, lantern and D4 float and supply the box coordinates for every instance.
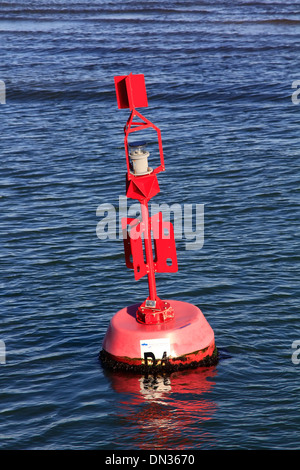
[99,73,218,373]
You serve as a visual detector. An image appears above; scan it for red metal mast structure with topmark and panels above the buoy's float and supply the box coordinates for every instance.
[115,74,178,324]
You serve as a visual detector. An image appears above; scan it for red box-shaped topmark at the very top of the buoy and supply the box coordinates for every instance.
[114,73,148,109]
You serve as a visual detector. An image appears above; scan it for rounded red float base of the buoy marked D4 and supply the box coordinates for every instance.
[99,300,218,373]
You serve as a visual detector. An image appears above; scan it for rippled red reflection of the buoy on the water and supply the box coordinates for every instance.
[106,368,217,450]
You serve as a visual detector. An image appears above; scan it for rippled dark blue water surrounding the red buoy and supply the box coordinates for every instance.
[0,0,300,451]
